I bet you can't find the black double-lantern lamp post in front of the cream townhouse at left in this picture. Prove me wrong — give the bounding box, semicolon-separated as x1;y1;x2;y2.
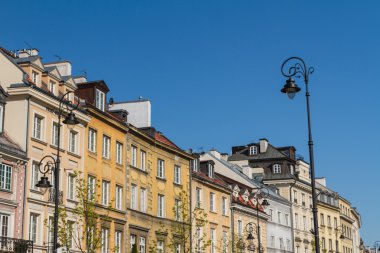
36;91;79;253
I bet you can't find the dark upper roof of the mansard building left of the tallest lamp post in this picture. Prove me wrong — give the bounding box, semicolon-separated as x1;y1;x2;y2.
228;143;289;161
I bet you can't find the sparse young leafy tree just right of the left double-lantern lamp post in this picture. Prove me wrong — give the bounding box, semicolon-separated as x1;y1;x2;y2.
52;172;107;253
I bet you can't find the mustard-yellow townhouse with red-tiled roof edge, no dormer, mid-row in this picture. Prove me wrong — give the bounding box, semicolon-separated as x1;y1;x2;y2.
127;125;192;253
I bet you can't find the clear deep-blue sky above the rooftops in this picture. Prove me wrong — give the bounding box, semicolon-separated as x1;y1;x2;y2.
0;0;380;245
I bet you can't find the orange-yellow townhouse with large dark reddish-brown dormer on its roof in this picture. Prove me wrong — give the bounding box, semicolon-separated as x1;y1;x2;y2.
76;81;128;253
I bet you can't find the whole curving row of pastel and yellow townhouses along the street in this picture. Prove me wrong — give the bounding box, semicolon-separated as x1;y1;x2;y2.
0;46;361;253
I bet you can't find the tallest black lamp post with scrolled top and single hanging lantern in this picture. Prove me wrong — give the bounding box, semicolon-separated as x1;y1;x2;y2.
281;57;320;253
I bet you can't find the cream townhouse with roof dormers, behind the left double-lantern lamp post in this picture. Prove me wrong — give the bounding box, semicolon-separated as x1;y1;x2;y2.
1;49;90;253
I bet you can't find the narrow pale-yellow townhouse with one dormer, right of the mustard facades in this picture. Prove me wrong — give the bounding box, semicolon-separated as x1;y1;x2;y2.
191;159;231;253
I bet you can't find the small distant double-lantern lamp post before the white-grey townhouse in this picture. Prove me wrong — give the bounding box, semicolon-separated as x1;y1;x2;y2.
246;187;269;253
